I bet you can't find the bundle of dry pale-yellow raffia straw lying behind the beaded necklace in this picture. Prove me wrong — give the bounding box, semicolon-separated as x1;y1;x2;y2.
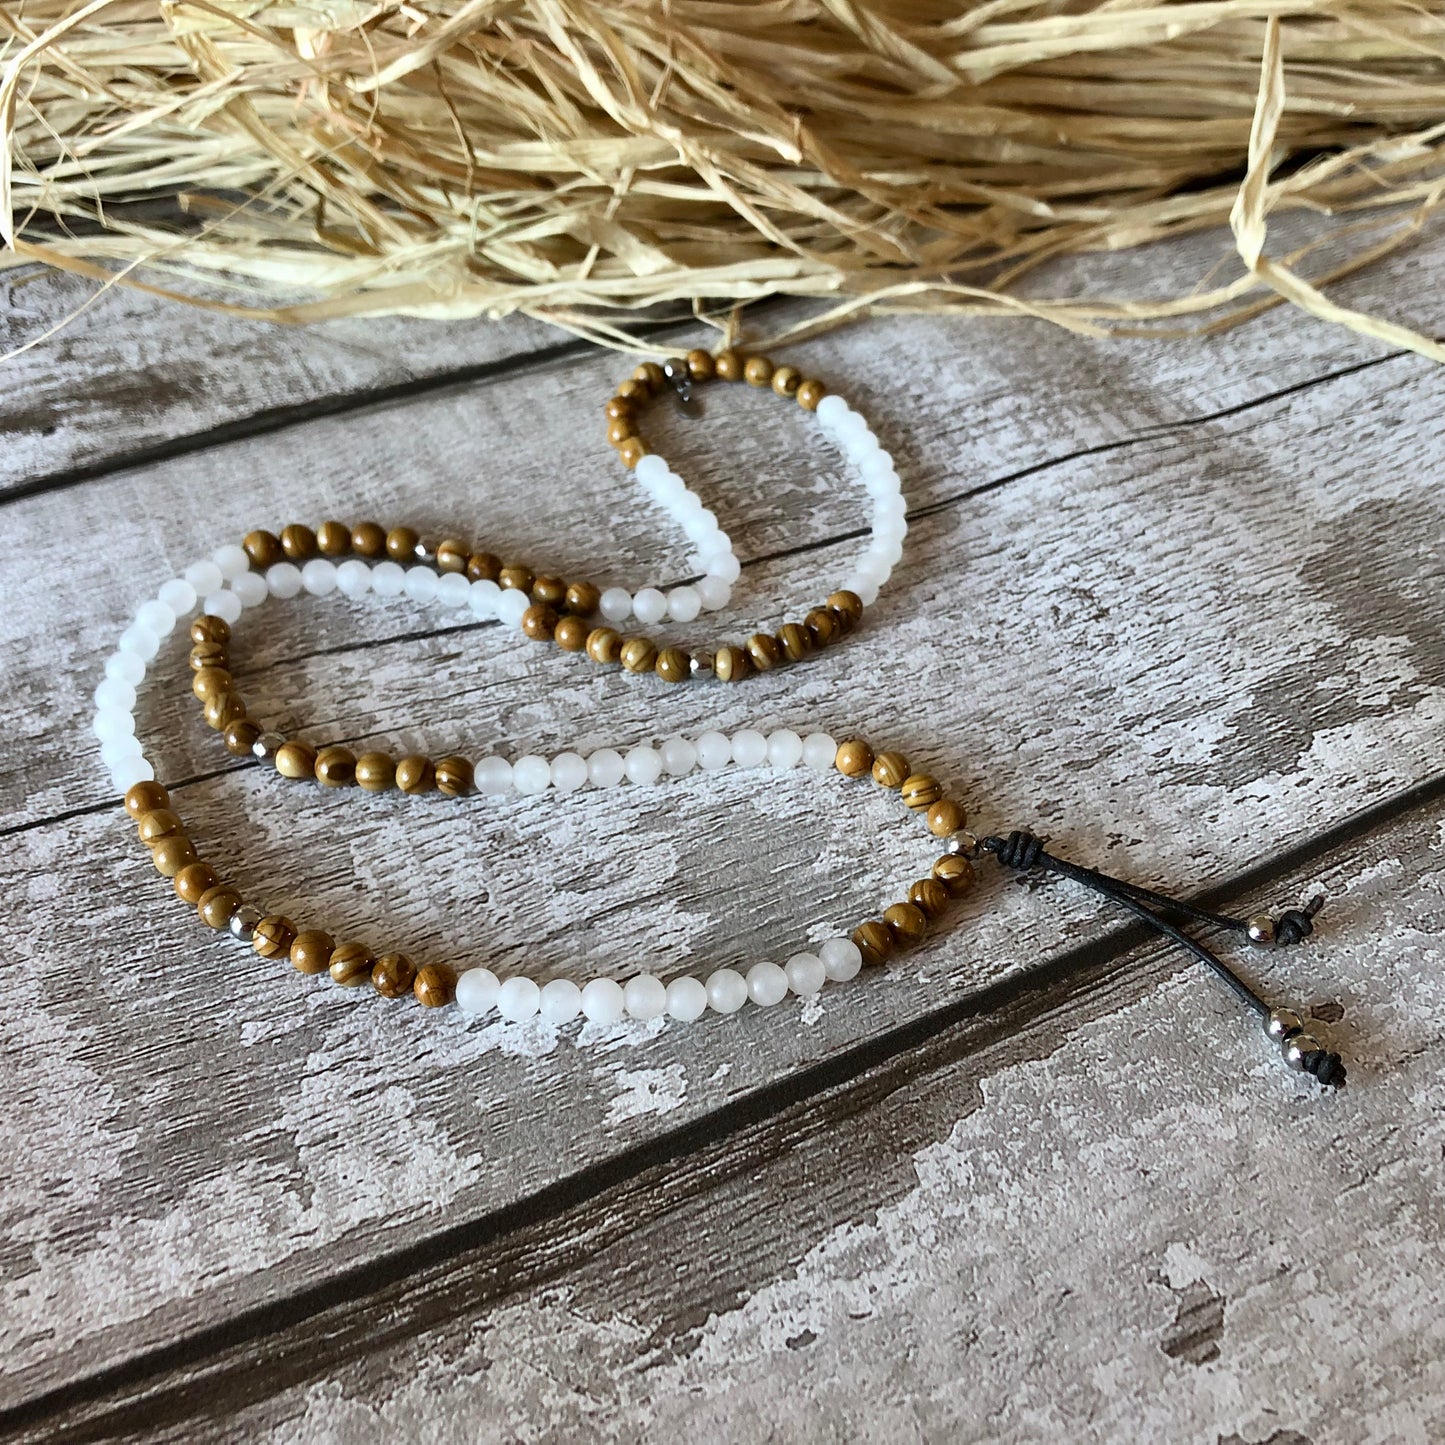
0;0;1445;360
